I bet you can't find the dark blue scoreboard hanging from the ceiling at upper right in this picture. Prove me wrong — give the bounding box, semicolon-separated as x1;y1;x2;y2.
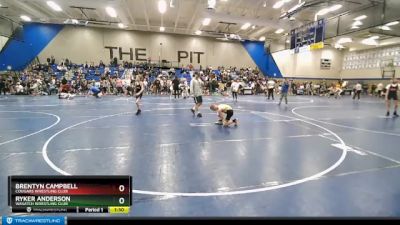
290;19;326;53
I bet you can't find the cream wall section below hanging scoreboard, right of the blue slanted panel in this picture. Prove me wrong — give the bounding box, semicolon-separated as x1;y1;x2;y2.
272;47;343;79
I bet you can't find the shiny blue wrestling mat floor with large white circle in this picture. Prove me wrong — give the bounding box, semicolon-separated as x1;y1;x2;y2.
0;96;400;217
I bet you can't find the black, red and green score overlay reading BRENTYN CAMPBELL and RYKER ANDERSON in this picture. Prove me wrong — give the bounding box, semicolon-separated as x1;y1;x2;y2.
8;176;132;214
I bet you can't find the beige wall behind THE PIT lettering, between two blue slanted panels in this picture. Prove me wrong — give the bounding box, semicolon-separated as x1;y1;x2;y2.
39;26;256;68
